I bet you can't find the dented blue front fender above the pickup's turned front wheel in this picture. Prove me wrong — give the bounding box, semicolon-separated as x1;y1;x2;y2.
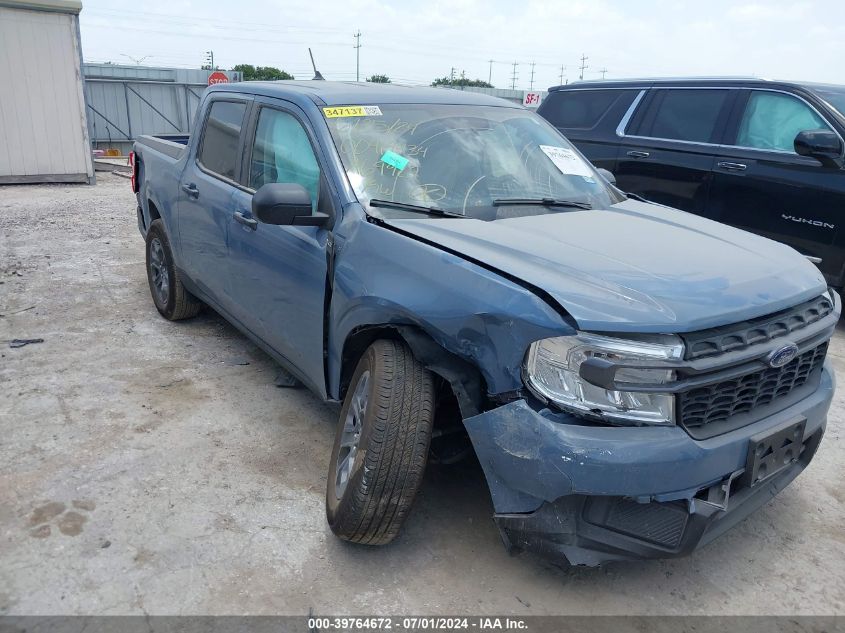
327;211;575;399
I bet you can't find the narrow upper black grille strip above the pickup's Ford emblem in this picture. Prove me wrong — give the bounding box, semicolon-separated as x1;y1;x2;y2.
681;295;833;360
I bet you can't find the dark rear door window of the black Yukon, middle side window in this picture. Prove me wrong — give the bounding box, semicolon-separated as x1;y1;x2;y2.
637;89;728;143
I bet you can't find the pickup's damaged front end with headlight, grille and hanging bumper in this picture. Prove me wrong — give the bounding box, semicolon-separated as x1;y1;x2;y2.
464;293;841;565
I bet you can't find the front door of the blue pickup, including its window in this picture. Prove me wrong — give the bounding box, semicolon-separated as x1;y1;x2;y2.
228;102;331;395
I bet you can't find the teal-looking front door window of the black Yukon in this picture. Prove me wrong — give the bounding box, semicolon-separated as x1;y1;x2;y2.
736;90;830;152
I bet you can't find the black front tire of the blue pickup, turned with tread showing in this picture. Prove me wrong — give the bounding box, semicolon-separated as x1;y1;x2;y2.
326;340;435;545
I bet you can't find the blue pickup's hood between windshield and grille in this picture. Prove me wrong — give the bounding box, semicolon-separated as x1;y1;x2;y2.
385;200;827;332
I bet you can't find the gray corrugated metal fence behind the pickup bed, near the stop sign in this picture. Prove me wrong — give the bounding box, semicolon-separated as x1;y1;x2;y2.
84;64;240;154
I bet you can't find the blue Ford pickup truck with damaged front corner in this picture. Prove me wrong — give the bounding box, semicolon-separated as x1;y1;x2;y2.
132;81;841;565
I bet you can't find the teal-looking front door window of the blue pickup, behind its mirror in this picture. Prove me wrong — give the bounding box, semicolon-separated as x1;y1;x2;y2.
249;108;320;209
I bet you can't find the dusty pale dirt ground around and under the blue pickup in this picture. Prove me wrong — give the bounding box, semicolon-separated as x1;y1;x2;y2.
0;173;845;615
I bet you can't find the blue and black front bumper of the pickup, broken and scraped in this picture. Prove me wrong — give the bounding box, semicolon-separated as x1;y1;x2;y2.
464;363;834;565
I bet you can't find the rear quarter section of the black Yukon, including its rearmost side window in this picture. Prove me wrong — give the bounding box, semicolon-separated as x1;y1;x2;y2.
537;88;642;171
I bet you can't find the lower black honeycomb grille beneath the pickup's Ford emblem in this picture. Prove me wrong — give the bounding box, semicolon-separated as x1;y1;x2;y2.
678;341;827;428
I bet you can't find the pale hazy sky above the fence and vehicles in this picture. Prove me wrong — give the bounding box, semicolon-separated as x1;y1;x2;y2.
81;0;845;90
